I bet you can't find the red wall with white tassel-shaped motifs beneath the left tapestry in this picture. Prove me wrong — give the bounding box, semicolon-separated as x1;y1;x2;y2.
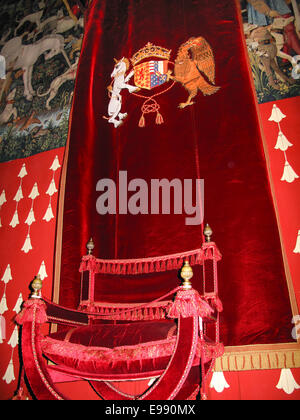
0;147;64;400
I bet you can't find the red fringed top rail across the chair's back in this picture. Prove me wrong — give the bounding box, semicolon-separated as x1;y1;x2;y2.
79;246;222;275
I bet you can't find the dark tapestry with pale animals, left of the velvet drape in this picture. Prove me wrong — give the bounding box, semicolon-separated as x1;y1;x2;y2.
0;0;84;162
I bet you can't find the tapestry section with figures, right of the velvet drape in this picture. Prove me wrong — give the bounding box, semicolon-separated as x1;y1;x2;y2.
240;0;300;103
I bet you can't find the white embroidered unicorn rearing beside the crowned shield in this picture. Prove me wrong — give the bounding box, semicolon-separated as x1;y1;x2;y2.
103;57;139;128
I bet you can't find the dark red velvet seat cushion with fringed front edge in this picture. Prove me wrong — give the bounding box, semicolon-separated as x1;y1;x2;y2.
42;320;199;380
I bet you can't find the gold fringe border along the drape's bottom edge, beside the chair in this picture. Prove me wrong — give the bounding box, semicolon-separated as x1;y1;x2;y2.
214;343;300;372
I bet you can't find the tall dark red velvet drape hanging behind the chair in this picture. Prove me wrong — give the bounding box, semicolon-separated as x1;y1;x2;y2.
60;0;292;345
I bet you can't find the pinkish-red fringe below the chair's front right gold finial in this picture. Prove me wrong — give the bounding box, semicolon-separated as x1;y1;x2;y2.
168;289;214;318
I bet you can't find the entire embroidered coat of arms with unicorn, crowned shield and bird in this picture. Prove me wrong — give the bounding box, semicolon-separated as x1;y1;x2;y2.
104;36;219;128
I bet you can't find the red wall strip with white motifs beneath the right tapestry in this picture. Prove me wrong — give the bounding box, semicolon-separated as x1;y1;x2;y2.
259;96;300;308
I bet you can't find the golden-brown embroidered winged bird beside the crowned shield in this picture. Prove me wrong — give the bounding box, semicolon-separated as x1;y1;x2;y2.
168;37;220;108
